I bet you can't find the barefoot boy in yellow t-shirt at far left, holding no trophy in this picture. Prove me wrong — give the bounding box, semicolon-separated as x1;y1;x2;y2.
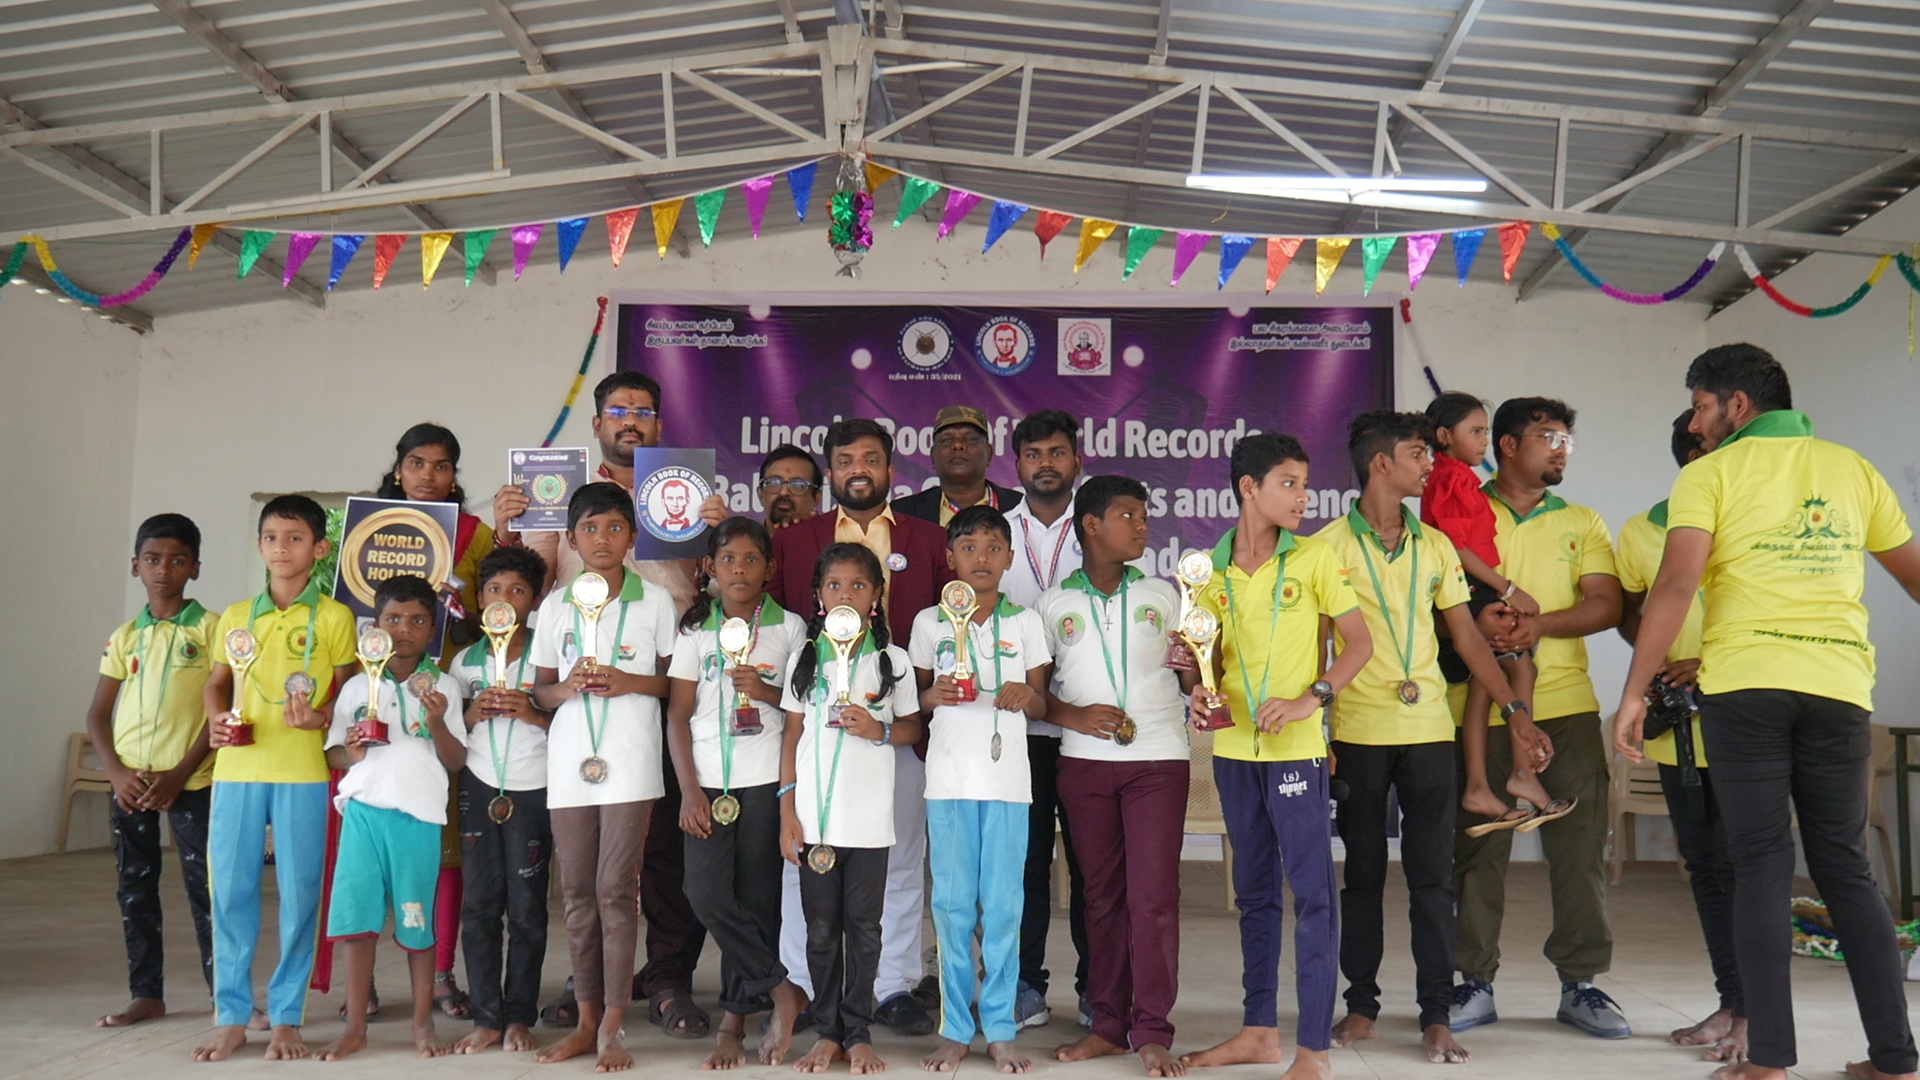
86;513;219;1028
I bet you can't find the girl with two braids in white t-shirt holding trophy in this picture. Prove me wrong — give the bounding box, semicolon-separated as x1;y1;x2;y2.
780;544;920;1074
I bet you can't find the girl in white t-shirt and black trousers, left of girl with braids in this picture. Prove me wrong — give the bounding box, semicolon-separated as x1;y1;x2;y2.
659;517;806;1068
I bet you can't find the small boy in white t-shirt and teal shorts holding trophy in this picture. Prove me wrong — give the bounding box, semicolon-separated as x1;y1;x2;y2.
317;575;467;1061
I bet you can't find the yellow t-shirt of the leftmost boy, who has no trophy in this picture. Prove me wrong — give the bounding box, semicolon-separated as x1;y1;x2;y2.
100;600;221;792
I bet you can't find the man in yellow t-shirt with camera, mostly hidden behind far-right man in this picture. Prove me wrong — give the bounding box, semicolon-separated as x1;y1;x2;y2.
1615;409;1747;1061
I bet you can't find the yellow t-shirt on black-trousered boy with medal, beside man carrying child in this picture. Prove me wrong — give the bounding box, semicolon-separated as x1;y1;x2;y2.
1313;505;1467;746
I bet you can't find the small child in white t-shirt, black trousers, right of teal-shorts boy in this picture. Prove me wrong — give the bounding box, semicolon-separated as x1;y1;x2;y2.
449;548;553;1053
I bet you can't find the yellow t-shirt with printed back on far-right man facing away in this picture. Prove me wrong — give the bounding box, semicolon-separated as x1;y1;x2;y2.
1667;409;1912;709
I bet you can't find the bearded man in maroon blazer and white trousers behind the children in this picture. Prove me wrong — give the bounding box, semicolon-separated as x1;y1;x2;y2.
766;419;954;1036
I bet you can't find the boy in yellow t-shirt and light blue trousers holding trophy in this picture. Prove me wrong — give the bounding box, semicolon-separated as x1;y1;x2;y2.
194;496;355;1061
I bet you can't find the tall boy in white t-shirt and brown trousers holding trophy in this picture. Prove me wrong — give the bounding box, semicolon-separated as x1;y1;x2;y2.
534;482;674;1072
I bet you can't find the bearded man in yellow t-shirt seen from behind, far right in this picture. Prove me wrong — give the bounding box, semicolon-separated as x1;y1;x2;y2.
1613;344;1920;1080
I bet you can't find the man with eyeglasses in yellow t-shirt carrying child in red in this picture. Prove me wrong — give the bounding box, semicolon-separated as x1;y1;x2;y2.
1448;398;1634;1040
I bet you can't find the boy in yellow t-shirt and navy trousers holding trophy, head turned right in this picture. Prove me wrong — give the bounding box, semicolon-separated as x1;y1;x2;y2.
1181;432;1373;1078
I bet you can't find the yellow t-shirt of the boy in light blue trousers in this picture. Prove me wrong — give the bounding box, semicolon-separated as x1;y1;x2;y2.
213;582;353;784
